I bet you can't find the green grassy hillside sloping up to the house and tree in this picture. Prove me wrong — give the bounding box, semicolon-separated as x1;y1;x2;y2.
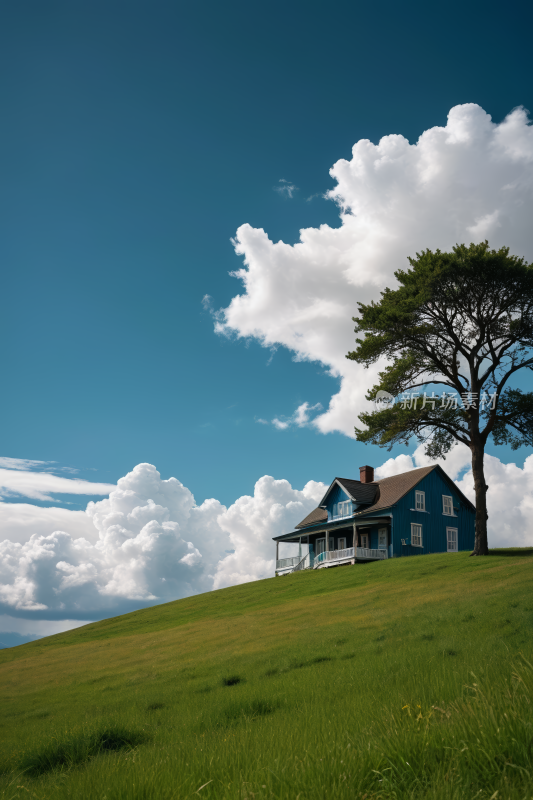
0;550;533;800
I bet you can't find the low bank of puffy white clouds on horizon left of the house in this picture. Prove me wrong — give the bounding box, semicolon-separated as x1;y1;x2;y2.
0;464;325;619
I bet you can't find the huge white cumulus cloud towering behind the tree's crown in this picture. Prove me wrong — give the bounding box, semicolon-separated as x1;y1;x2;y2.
215;103;533;436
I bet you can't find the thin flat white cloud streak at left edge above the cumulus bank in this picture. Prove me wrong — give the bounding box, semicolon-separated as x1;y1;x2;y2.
0;468;115;501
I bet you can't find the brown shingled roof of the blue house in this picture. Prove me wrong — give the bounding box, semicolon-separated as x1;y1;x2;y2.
295;464;474;528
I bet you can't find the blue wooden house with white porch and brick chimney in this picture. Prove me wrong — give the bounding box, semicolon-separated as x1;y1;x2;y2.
274;464;476;575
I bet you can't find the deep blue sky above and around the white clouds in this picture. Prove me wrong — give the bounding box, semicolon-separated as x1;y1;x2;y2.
0;0;533;635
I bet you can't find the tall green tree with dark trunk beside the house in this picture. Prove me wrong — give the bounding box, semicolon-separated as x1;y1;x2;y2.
347;242;533;555
